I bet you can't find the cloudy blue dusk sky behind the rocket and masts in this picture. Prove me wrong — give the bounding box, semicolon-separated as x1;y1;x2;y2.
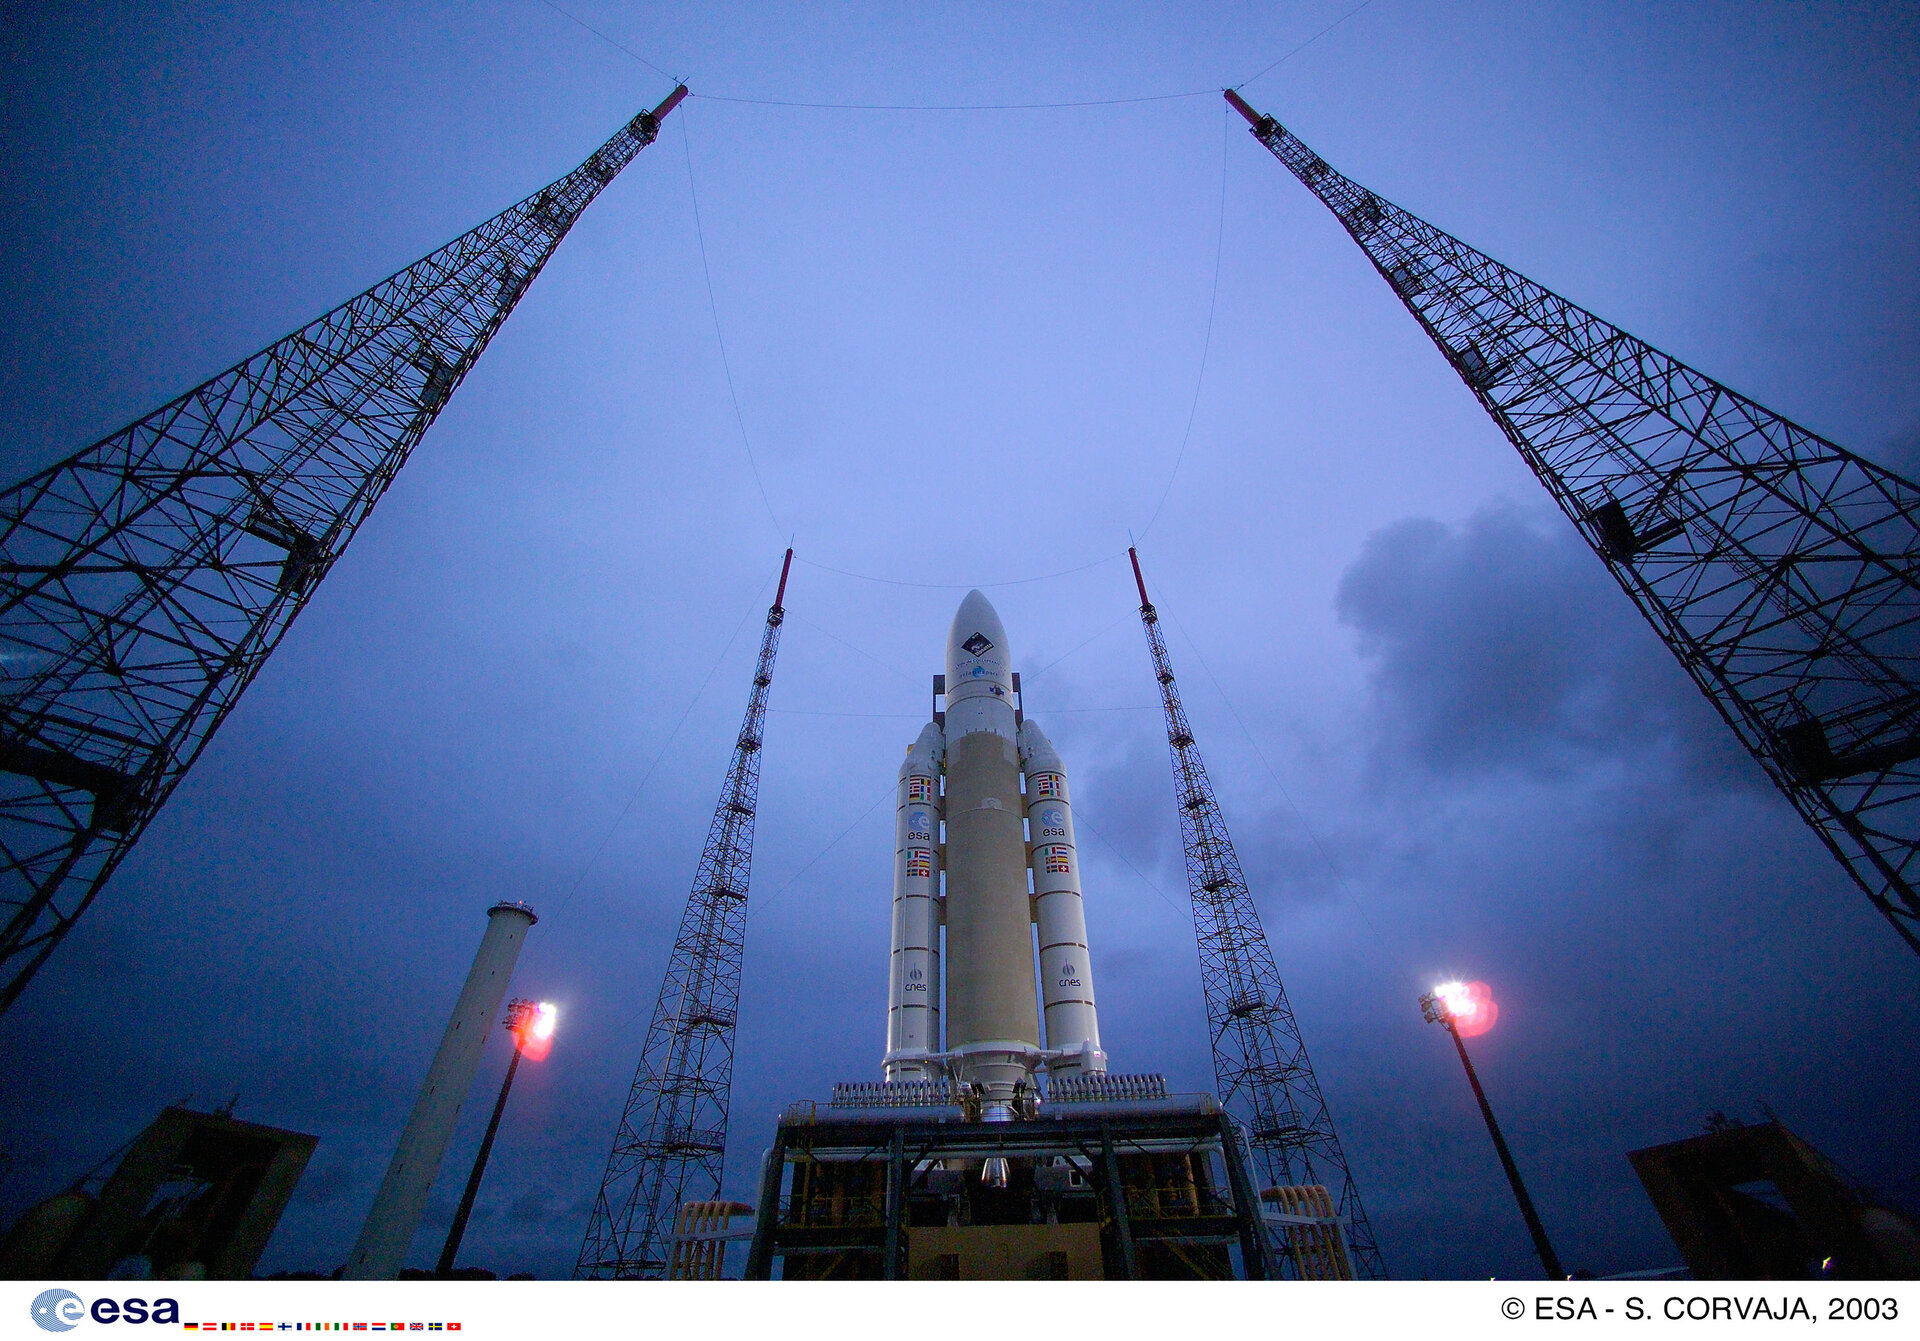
0;0;1920;1278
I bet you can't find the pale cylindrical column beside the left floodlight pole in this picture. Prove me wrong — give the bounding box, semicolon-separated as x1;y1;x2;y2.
346;903;538;1280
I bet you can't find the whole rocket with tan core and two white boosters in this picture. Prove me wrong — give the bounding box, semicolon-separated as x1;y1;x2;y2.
885;592;1106;1120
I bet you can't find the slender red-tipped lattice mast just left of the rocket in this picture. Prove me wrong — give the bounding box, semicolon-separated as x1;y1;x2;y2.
574;549;793;1280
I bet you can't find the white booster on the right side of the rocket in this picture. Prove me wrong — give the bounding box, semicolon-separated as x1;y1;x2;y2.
1020;717;1106;1076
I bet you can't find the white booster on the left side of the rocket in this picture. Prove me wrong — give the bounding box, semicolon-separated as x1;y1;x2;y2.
885;722;947;1080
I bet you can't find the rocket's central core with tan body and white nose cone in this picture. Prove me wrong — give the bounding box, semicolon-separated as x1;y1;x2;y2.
945;592;1041;1118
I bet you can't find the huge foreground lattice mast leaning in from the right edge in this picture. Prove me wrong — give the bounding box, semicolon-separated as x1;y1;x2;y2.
1227;90;1920;951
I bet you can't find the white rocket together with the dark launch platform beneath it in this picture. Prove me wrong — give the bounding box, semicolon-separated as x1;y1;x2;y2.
745;592;1352;1280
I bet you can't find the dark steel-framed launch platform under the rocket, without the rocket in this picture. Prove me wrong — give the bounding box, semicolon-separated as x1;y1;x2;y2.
745;1076;1344;1280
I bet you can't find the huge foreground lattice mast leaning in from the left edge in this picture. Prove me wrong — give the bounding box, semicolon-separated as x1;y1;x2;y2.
0;86;687;1011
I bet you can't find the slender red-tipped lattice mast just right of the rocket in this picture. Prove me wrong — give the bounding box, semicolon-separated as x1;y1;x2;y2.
1127;549;1386;1280
